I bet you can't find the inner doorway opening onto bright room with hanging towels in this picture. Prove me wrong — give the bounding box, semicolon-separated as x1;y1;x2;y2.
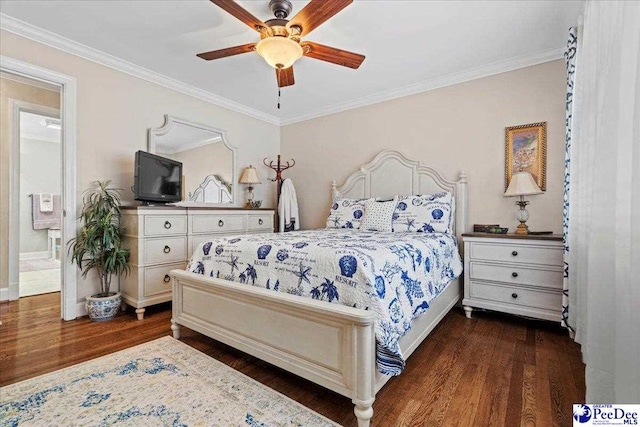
12;110;63;298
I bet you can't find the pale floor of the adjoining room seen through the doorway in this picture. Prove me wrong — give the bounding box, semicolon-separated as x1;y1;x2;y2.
18;258;60;297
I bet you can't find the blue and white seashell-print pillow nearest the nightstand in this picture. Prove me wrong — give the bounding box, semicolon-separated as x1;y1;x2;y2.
393;192;455;234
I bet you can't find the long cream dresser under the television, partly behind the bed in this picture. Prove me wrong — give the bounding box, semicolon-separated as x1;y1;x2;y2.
120;206;274;320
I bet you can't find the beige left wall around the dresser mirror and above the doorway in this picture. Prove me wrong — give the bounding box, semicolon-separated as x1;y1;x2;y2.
0;31;280;302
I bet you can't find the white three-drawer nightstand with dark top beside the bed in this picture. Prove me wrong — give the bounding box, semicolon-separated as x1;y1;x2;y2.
462;233;563;322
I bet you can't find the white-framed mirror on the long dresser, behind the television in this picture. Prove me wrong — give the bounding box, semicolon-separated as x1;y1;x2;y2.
148;114;237;205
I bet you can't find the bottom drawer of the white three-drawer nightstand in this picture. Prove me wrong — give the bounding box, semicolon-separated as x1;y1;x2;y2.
470;281;562;313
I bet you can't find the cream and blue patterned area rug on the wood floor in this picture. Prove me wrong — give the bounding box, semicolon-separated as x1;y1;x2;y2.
0;337;337;427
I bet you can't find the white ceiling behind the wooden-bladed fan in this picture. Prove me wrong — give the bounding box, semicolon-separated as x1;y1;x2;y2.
0;0;583;124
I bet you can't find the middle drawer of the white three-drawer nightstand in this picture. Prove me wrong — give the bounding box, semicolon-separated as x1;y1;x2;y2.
469;261;562;290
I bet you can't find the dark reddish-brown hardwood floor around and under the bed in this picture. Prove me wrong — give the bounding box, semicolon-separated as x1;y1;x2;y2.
0;293;585;427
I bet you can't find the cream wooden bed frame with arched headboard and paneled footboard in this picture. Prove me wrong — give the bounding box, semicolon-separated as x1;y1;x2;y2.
171;150;467;426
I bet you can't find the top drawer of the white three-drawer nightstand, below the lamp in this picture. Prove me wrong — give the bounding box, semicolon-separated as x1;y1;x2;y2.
470;242;563;267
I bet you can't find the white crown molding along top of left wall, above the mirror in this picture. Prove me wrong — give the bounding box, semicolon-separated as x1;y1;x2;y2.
0;13;281;126
